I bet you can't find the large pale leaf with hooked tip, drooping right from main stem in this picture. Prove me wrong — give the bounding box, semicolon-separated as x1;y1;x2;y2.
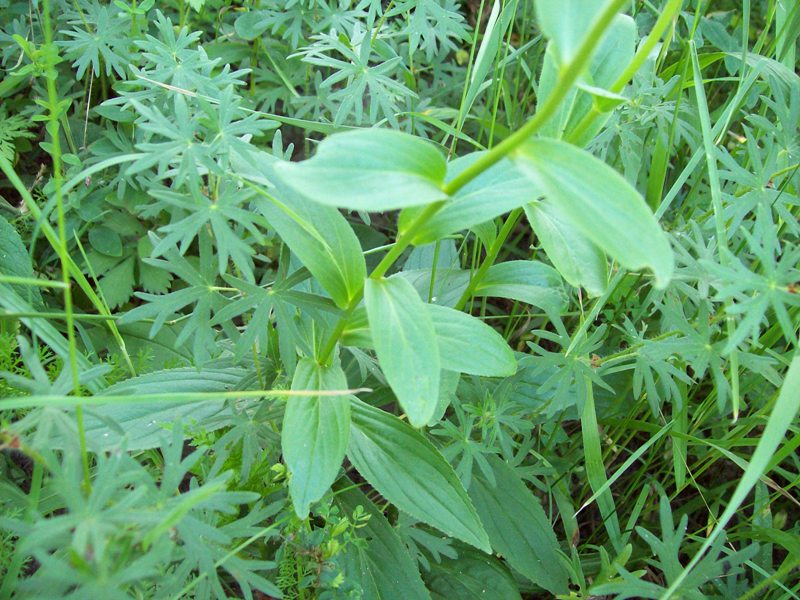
515;138;674;287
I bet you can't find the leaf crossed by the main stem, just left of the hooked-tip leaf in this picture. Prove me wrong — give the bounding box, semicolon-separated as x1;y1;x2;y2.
398;158;542;245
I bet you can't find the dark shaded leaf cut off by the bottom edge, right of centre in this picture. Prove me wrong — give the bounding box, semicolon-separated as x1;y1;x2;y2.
425;547;521;600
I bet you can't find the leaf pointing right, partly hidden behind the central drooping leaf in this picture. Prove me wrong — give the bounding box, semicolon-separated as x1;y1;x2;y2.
425;304;517;377
